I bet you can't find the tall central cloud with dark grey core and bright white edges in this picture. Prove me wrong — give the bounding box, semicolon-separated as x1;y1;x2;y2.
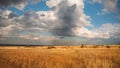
47;0;92;36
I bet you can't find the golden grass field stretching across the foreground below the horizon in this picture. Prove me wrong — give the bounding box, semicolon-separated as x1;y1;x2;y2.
0;45;120;68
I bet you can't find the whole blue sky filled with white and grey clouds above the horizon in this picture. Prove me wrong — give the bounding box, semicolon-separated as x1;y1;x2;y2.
0;0;120;45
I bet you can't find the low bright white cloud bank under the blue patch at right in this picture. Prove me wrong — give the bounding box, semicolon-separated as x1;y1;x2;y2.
74;23;120;39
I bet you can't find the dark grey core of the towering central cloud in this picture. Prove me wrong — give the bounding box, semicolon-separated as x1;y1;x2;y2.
53;1;80;36
